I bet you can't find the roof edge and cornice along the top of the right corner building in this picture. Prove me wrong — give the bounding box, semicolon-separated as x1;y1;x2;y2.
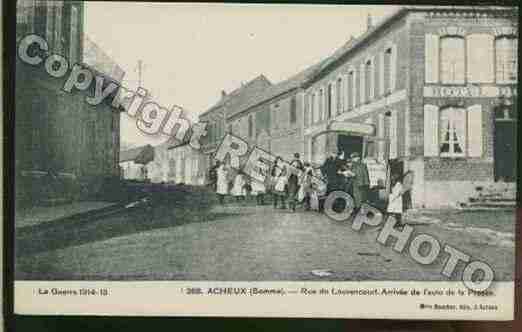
309;5;510;82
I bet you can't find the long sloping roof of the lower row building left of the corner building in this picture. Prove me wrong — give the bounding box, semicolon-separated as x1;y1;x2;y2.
227;58;328;117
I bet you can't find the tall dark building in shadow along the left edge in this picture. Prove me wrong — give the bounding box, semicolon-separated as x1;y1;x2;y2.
15;0;120;204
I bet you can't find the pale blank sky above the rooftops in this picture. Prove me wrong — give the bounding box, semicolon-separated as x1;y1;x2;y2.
84;1;396;146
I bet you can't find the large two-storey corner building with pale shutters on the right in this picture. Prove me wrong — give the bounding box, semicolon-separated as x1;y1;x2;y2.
304;6;518;207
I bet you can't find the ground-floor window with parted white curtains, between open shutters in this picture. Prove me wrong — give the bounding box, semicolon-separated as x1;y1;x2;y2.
439;107;466;157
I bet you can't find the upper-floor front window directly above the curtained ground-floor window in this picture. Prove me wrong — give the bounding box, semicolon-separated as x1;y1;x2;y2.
440;36;465;84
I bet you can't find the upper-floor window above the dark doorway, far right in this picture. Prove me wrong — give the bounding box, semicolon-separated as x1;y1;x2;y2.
495;36;518;83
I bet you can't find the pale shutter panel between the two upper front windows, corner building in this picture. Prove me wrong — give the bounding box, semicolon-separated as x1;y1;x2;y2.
467;34;495;83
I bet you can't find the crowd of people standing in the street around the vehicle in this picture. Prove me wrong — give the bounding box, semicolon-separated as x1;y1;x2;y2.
206;151;402;219
